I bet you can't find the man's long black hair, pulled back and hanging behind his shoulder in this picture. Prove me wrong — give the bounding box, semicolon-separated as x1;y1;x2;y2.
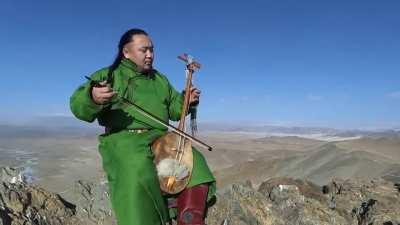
107;28;148;83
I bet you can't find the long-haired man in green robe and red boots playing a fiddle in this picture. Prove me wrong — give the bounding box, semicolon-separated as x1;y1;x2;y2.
70;29;215;225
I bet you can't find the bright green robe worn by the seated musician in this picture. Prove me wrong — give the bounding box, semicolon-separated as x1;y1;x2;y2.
70;59;216;225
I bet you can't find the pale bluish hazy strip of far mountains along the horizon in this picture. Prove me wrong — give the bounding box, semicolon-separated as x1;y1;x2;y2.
0;116;400;141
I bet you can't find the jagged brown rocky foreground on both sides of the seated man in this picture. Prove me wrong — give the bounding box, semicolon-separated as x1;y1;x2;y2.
0;168;400;225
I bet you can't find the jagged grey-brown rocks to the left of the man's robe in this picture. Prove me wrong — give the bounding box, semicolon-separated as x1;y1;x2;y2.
0;168;116;225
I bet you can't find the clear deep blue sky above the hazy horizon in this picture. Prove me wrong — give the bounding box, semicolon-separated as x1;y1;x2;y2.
0;0;400;129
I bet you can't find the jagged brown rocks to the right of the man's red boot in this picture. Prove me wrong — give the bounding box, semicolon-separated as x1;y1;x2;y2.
207;178;400;225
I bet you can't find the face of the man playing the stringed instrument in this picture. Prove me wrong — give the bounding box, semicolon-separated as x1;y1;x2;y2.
123;34;154;72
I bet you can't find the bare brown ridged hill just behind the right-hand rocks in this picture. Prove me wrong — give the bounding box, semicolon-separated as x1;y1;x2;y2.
215;140;400;186
